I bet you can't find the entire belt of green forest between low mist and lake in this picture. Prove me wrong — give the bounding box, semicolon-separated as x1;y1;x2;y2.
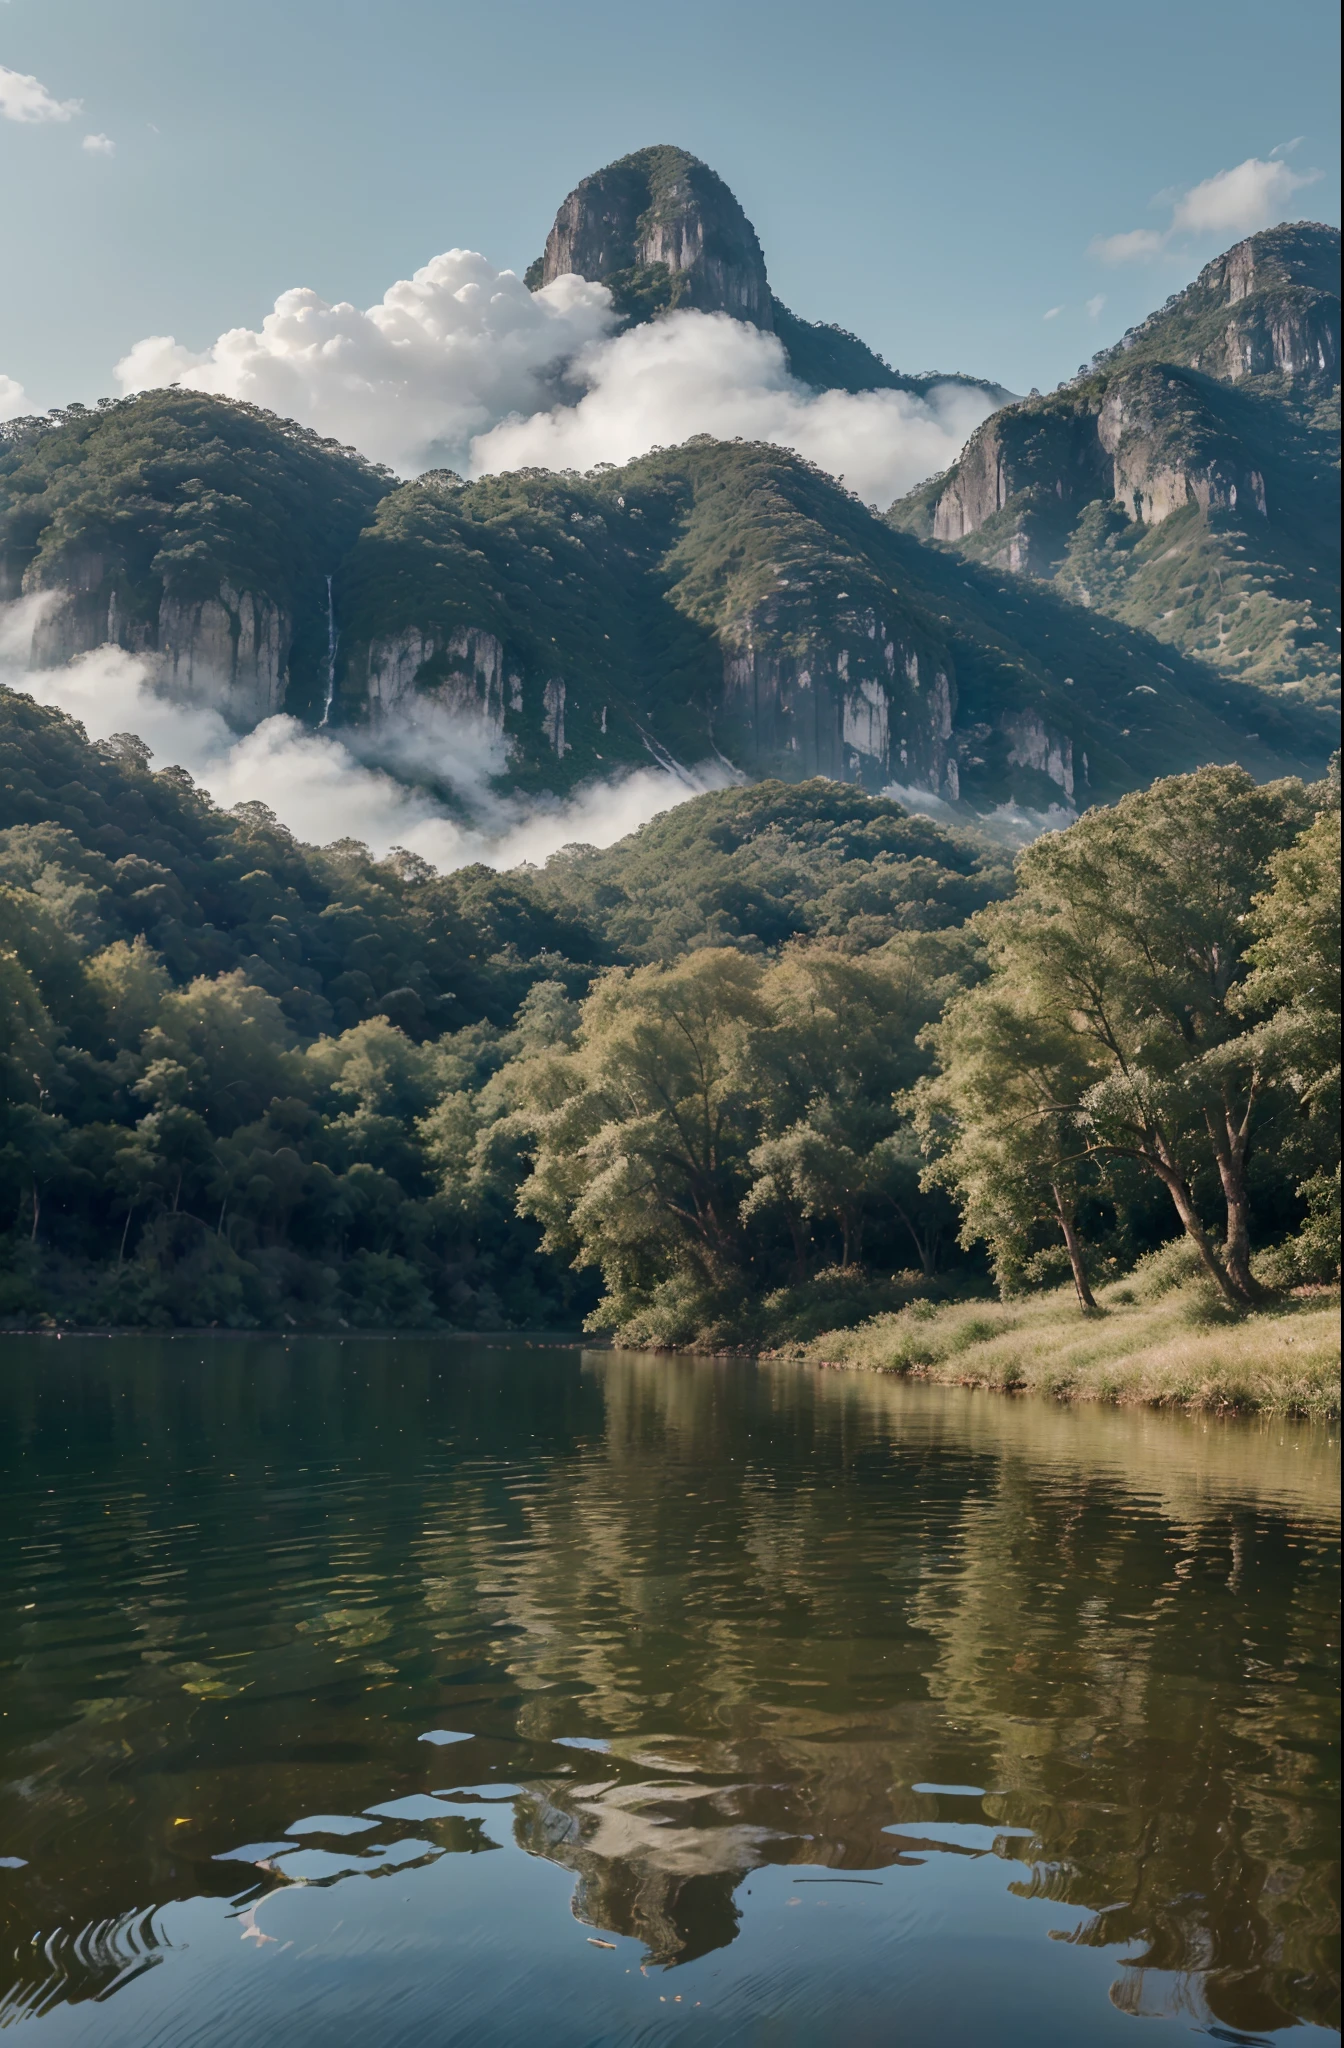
0;692;1340;1343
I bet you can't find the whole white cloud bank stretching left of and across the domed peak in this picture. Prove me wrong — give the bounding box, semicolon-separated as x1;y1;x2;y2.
117;250;994;502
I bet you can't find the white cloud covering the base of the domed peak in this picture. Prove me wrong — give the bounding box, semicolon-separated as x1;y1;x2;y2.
471;311;996;504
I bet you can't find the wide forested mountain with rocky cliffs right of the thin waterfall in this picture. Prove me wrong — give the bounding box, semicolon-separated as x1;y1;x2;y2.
329;444;1328;813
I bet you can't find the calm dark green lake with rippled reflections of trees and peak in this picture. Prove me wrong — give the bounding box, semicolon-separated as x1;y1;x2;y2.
0;1337;1338;2048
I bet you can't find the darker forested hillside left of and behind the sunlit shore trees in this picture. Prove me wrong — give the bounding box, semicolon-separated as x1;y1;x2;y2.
0;690;995;1329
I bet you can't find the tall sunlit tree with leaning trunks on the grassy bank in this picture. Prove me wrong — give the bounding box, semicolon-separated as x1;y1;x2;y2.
946;768;1307;1303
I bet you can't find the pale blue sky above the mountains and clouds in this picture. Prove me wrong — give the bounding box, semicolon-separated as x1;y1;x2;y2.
0;0;1340;410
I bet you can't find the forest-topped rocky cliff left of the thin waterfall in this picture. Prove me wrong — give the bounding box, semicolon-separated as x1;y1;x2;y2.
0;389;391;729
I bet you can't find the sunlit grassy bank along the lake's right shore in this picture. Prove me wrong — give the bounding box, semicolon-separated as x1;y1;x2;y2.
795;1274;1340;1421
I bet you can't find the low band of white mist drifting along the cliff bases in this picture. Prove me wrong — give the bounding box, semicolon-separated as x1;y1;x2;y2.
0;596;731;870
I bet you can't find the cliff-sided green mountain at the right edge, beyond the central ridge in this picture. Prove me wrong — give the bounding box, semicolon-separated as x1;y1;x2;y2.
889;223;1340;700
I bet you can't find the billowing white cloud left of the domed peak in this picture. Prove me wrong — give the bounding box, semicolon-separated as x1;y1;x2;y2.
117;250;615;471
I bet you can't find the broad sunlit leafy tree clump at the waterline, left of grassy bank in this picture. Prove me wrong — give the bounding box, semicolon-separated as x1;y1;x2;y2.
506;936;969;1343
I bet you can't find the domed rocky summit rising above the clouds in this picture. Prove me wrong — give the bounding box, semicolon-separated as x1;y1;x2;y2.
541;145;774;328
